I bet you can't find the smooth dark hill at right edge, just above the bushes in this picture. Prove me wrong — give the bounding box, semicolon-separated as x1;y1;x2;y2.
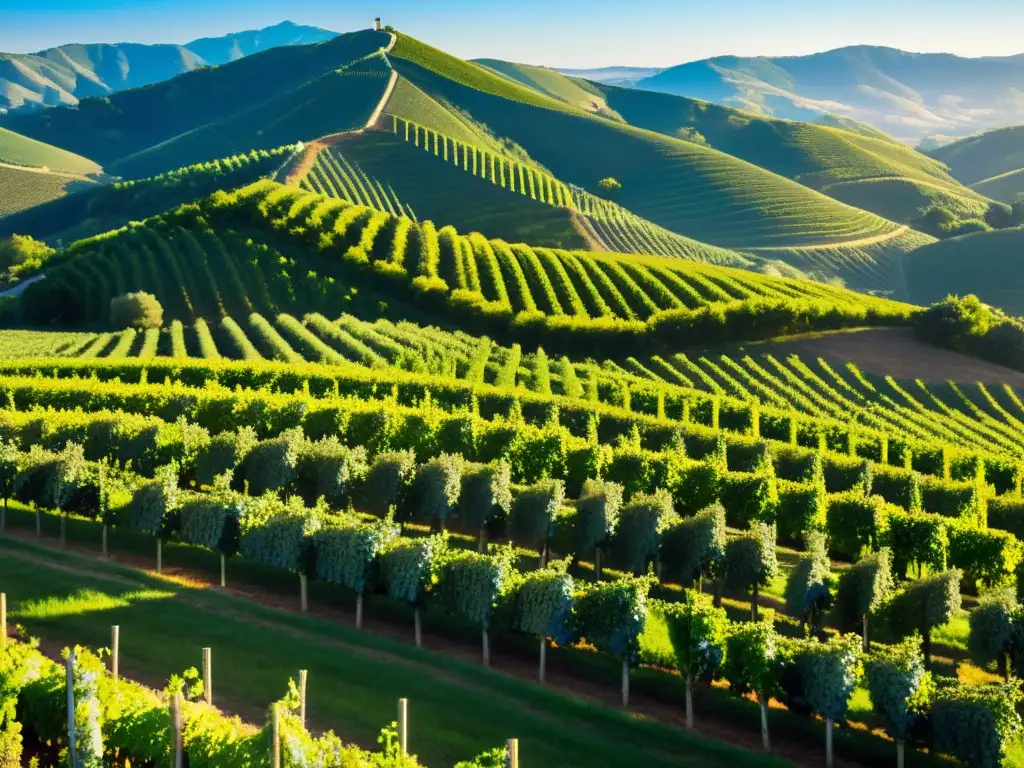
904;228;1024;315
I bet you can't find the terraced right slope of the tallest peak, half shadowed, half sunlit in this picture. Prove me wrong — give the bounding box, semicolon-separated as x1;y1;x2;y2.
392;36;929;290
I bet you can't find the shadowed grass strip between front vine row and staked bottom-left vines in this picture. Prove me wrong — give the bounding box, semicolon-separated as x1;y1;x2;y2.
0;541;784;768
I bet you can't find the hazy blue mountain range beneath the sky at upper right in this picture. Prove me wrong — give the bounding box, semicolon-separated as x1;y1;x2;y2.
635;46;1024;141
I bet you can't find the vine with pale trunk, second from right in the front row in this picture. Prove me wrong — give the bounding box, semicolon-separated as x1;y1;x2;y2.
864;636;932;768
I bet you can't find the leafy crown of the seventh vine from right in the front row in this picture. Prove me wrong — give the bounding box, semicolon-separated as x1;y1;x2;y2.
512;561;574;645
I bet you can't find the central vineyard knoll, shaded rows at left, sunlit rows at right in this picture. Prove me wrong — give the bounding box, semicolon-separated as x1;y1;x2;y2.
24;181;906;338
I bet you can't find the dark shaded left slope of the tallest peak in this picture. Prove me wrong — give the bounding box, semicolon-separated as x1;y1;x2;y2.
5;31;390;177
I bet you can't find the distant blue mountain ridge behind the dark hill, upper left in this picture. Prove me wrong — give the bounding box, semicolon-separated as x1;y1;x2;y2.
0;22;337;114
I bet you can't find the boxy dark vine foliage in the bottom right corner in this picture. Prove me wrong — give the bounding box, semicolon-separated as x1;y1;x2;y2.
932;681;1022;768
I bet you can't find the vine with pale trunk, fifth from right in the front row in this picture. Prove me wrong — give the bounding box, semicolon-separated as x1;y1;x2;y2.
662;590;729;728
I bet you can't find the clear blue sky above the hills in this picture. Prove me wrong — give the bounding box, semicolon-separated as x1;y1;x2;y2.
6;0;1024;67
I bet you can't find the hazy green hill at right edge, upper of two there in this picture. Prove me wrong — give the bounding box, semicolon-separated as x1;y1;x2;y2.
930;126;1024;203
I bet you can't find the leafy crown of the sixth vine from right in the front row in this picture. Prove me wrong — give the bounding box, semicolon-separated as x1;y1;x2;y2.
574;575;655;664
